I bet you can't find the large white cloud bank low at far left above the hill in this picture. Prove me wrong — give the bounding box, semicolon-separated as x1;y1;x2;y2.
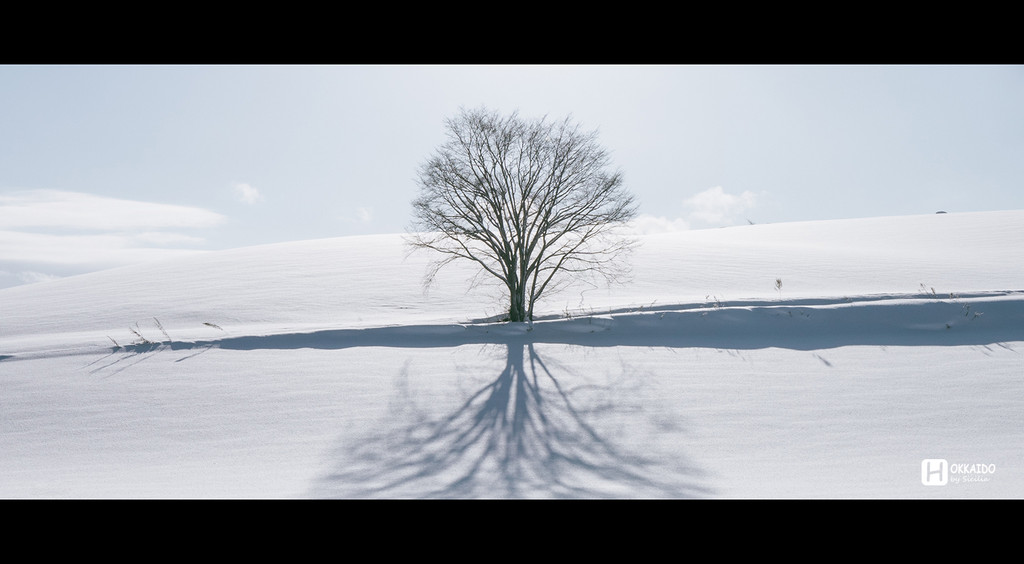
0;189;226;287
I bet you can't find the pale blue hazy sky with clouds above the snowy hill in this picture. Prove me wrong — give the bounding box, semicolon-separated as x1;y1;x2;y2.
0;64;1024;288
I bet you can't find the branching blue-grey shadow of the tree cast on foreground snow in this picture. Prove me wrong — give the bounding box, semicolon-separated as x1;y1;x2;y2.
311;343;709;498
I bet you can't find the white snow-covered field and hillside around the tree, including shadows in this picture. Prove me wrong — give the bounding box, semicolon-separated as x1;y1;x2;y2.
0;211;1024;498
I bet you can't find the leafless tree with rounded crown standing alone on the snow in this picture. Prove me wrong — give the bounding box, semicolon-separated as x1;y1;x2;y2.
408;109;636;321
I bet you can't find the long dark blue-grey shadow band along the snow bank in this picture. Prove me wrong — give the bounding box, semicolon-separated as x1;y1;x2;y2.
155;299;1024;350
